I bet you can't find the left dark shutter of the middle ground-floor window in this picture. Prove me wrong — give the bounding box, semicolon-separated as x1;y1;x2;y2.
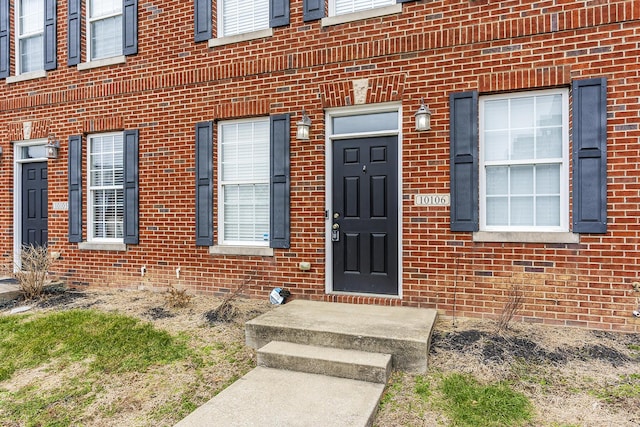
196;122;213;246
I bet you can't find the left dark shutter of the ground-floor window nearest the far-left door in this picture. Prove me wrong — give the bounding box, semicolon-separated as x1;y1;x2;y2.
67;135;82;243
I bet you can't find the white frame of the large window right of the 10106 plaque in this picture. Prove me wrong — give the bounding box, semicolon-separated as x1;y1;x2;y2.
479;89;570;233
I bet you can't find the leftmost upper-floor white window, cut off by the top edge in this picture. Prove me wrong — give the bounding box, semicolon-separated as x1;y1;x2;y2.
16;0;44;74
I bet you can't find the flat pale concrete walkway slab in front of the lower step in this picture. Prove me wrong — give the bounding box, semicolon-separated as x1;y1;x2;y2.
176;366;385;427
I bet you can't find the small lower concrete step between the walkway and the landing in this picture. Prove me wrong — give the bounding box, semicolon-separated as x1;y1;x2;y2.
258;341;391;384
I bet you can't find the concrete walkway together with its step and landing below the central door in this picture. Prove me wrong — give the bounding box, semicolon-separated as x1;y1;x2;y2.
176;300;436;427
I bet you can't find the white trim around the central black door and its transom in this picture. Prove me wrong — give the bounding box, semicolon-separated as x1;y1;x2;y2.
325;102;403;299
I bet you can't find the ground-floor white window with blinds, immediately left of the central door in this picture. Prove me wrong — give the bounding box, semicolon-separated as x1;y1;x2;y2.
218;118;270;246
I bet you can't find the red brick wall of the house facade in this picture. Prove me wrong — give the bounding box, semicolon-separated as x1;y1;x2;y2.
0;0;640;331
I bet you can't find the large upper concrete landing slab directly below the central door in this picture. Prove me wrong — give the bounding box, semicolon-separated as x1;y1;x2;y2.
245;300;437;373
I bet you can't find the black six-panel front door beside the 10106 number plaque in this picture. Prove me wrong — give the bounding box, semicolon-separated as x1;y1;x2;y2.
330;136;398;295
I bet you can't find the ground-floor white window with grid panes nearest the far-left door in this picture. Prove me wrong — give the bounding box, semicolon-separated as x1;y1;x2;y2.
88;133;124;242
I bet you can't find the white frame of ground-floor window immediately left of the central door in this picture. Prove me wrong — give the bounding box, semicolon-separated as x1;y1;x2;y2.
217;117;271;248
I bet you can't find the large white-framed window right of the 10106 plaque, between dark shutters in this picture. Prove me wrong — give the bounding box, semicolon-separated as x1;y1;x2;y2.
480;90;569;231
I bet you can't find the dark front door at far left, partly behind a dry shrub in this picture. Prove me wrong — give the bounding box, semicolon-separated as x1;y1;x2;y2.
22;162;49;246
